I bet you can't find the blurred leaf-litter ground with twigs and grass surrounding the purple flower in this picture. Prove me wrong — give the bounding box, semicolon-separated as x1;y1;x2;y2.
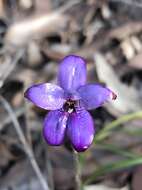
0;0;142;190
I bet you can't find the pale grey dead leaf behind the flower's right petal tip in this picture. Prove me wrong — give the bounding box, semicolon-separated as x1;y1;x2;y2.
94;52;142;114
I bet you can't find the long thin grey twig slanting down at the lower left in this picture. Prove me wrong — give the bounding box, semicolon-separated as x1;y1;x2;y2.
0;95;49;190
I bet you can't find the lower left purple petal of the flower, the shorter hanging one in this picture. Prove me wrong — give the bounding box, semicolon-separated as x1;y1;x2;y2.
43;110;68;146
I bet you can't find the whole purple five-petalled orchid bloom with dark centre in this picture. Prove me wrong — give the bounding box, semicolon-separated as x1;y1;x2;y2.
25;55;116;152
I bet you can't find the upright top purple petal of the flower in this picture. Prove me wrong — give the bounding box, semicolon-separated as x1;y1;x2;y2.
58;55;86;91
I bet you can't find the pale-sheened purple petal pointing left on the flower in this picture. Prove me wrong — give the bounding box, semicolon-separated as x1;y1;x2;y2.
25;83;65;110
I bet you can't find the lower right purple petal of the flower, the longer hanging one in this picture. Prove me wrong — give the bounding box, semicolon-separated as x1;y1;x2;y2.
67;110;94;152
